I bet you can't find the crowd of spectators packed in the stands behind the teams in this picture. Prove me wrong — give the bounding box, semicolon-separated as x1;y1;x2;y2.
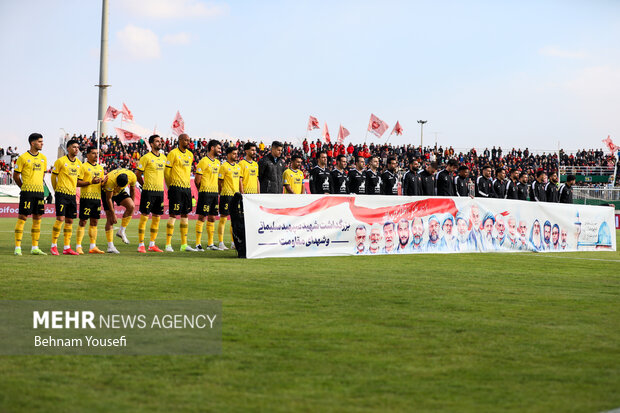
12;134;620;186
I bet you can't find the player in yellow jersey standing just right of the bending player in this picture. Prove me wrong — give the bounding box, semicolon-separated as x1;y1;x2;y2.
136;135;166;253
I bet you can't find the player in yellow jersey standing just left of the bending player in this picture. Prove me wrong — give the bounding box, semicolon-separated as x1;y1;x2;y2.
75;146;105;255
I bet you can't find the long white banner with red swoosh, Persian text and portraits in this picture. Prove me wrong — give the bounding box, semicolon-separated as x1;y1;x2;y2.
243;194;616;258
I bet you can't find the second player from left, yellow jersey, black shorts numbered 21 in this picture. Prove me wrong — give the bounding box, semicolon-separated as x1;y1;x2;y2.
50;139;82;255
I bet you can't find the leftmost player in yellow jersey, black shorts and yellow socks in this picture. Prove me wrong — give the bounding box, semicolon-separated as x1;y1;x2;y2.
13;133;47;255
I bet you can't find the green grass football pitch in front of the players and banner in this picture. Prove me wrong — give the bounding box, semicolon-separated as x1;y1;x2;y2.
0;219;620;412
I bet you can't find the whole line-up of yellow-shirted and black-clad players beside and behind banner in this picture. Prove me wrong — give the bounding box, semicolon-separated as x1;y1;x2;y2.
14;133;574;255
